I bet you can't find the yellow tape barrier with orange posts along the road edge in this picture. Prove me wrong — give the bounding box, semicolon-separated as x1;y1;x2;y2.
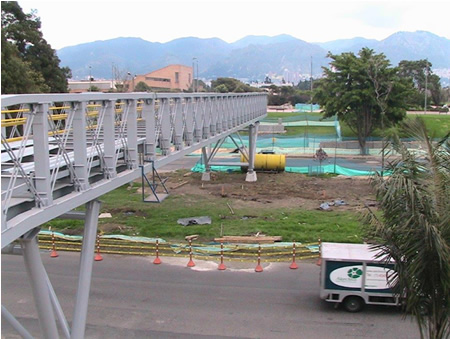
39;231;319;263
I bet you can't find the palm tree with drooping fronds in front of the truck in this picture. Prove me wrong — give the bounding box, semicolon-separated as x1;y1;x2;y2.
366;118;450;339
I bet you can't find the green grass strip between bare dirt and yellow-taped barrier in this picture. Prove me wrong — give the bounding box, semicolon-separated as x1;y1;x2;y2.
44;184;362;243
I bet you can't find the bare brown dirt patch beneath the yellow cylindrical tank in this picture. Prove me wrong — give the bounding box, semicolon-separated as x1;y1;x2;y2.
164;172;375;214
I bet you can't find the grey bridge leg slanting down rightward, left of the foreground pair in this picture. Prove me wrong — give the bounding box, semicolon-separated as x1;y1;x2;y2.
20;227;59;339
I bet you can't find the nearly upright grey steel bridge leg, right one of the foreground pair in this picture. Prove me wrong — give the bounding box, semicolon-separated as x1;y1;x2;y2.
71;200;101;339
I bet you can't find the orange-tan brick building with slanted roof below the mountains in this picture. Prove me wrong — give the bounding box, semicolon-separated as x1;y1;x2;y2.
129;65;193;92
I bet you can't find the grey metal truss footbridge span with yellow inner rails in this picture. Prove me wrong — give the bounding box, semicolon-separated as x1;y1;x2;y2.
1;93;267;247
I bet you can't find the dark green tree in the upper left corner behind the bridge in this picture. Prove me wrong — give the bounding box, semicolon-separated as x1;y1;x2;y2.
1;1;71;94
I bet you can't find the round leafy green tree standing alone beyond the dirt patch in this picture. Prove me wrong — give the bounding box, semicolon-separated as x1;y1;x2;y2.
313;48;411;154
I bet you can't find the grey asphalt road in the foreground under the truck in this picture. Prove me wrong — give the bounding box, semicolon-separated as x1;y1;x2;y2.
1;252;419;339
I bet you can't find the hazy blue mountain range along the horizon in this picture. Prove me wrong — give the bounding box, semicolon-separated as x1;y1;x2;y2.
57;31;450;81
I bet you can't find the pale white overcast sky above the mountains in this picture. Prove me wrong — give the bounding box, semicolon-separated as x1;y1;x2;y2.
19;0;450;49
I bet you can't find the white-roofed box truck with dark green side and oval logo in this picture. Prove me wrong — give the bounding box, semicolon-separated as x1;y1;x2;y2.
320;242;401;312
